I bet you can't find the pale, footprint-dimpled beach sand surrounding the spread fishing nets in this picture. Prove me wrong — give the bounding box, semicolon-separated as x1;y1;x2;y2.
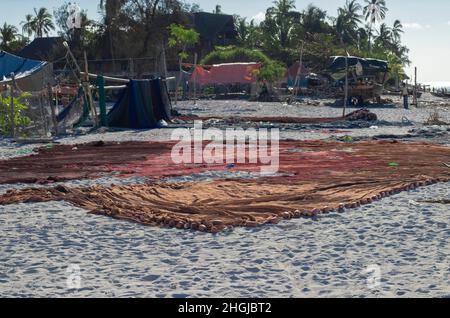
0;99;450;297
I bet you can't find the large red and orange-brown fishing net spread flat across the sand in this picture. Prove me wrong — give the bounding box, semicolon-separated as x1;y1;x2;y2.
0;141;450;233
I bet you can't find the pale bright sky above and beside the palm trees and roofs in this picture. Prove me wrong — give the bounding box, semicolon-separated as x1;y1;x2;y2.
0;0;450;82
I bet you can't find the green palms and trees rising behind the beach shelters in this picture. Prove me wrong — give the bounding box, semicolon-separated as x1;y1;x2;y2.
0;0;411;79
